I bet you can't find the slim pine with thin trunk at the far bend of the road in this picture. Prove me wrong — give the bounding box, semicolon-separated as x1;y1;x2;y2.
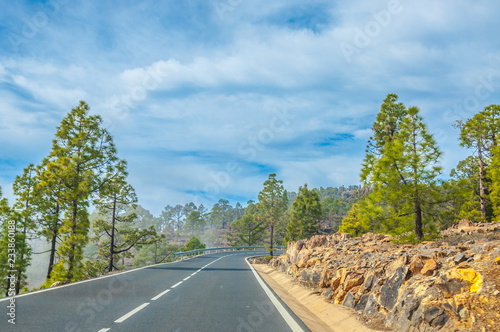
257;173;287;256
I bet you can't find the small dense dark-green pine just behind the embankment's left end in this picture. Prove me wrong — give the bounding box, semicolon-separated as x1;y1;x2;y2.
284;184;322;244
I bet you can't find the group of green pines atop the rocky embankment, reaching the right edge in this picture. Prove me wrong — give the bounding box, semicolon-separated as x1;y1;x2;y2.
340;94;500;241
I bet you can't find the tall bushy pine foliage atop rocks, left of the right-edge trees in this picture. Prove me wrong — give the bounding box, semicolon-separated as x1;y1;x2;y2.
348;94;441;239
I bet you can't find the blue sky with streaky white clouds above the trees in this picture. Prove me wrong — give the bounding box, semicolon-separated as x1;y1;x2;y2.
0;0;500;215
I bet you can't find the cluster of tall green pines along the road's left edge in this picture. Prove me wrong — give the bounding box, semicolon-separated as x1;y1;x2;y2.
0;101;159;294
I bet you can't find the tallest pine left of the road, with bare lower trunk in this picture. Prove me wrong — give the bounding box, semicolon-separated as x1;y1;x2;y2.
47;101;117;281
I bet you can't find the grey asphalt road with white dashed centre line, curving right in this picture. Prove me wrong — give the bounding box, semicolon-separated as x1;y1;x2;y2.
0;252;308;332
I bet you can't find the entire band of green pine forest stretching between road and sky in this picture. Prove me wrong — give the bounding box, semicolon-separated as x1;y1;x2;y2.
0;94;500;295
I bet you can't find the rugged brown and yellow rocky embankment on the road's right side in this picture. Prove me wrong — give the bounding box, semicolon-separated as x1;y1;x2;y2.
269;221;500;332
